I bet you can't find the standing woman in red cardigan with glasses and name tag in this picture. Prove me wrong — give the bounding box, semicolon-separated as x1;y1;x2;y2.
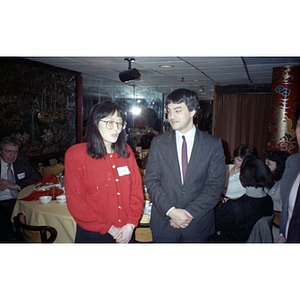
65;101;144;243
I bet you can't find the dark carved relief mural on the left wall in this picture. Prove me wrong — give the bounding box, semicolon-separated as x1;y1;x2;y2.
0;58;77;158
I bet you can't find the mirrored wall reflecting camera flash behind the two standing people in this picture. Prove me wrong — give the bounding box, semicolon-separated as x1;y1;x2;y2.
82;74;166;150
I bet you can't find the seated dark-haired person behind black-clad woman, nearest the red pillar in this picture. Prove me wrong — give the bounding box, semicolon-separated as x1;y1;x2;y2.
265;150;290;212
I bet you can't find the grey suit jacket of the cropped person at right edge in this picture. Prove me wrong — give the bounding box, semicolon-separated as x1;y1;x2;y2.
279;152;300;238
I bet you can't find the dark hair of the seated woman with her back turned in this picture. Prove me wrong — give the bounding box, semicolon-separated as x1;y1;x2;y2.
240;156;274;188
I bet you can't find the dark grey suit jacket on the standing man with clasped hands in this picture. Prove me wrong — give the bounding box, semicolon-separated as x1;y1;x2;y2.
144;129;225;239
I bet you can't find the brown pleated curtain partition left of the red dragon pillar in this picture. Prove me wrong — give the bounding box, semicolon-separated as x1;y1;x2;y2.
213;92;272;163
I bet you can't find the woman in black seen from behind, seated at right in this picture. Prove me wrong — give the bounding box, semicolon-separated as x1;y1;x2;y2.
210;157;274;243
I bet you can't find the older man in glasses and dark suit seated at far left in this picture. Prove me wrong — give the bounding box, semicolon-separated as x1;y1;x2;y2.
0;136;41;238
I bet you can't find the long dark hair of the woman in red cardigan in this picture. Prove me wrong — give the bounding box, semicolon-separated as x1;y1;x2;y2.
85;101;129;159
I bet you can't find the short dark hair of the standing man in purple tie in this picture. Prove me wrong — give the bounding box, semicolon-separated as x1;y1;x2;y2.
166;89;199;116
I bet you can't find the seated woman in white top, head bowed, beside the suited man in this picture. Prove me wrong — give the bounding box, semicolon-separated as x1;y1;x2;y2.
221;145;258;201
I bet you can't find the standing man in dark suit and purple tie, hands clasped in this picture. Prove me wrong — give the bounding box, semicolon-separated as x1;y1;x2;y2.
144;89;225;243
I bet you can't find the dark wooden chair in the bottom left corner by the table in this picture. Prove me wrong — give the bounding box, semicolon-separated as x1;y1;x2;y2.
13;213;57;243
